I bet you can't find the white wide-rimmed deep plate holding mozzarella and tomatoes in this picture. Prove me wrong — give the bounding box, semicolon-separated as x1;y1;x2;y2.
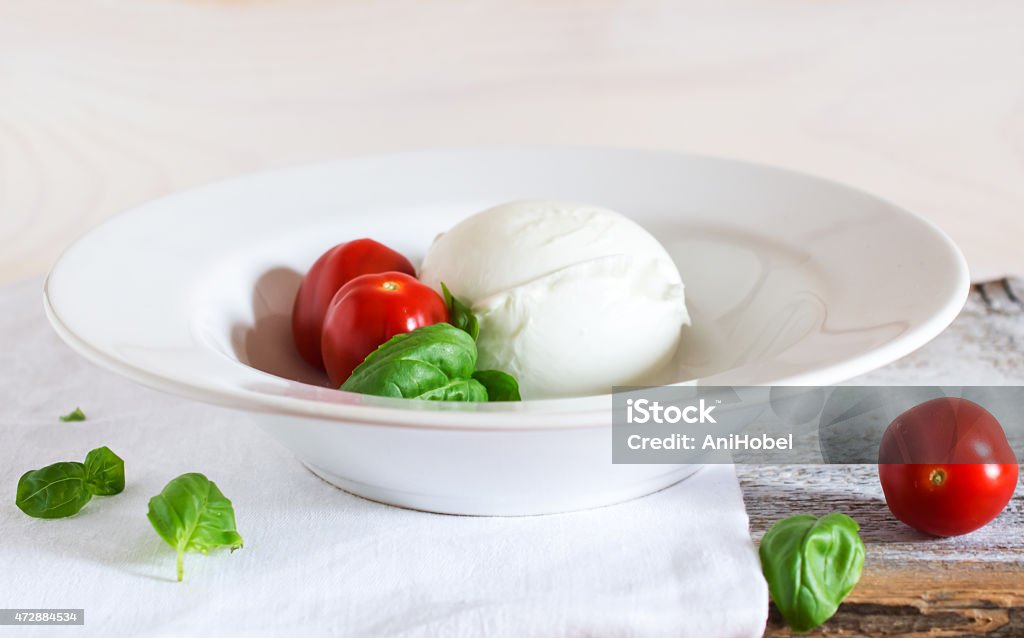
46;147;968;514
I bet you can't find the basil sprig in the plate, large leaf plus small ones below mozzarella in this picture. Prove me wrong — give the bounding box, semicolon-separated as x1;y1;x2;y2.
341;324;519;401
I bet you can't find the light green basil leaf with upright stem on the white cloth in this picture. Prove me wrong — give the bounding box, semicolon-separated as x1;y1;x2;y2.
146;473;242;582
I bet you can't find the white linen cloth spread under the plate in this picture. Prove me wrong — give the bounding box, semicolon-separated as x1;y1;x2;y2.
0;280;768;638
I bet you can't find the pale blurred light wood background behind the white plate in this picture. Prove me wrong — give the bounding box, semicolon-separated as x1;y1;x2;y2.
0;0;1024;283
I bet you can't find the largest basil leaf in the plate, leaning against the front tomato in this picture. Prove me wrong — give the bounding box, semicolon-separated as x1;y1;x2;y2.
341;324;476;400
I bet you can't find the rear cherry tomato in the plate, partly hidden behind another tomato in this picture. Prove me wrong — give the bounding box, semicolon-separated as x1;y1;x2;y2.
292;240;416;370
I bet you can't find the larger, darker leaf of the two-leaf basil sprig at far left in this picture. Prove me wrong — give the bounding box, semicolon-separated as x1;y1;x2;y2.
14;461;92;518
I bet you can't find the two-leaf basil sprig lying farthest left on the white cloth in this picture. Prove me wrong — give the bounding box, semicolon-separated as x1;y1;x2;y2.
14;446;125;518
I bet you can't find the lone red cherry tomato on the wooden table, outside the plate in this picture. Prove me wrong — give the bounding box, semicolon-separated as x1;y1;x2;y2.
879;397;1018;537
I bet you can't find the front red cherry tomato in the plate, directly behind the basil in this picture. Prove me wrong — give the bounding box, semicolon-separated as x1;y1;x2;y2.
321;272;449;387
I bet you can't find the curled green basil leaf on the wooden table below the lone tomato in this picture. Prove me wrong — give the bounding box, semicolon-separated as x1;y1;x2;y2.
759;513;864;632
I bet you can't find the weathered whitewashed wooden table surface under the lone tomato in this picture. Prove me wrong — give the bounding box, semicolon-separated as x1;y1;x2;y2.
753;286;1024;638
